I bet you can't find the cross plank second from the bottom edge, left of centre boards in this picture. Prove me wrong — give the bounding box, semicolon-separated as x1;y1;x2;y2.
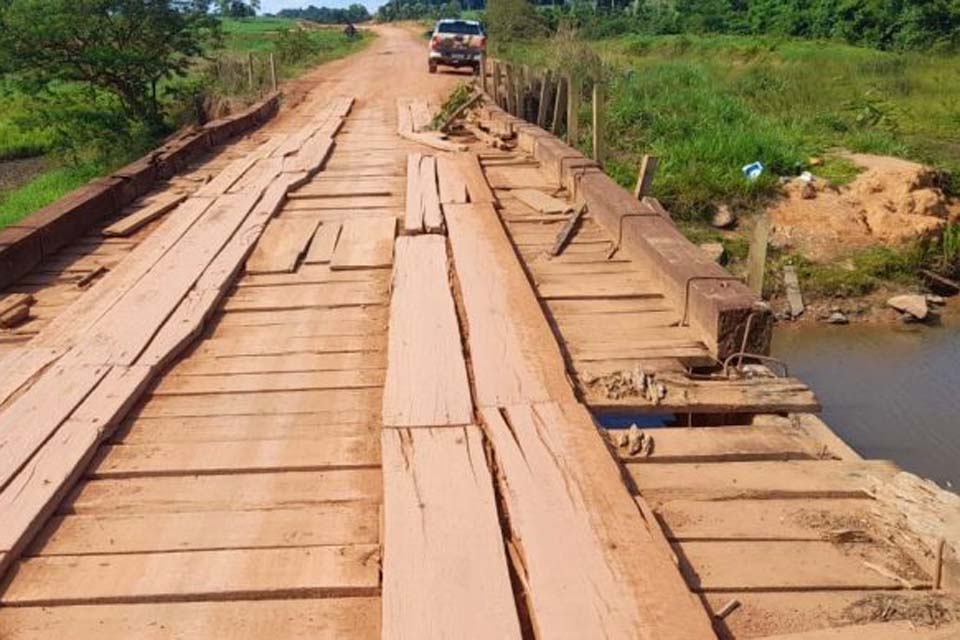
0;545;380;606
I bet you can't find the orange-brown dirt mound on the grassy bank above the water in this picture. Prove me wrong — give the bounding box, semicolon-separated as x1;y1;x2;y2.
770;154;960;261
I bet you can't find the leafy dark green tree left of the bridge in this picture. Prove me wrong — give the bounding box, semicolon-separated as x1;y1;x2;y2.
0;0;218;128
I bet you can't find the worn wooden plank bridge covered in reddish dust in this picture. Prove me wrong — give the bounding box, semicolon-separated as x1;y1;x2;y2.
0;28;960;640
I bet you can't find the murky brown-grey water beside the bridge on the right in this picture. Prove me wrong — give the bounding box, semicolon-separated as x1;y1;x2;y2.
773;314;960;491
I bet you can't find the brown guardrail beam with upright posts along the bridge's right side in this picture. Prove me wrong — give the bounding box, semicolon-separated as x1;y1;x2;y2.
481;59;773;361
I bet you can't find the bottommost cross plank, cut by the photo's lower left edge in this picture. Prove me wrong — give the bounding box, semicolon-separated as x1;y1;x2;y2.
0;597;380;640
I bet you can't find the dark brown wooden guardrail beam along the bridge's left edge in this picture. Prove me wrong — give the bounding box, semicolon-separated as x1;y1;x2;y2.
0;93;280;287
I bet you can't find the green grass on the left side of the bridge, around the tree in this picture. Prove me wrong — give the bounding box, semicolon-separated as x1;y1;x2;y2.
0;18;373;228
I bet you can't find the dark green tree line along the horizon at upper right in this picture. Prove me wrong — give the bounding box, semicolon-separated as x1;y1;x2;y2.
377;0;960;50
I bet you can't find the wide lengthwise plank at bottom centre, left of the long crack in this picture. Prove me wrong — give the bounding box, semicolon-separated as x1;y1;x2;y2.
382;426;521;638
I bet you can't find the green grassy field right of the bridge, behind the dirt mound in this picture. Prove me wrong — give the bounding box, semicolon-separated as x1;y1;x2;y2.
500;35;960;295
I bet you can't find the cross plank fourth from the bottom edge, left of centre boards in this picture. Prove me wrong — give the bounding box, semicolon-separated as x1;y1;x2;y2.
63;469;383;515
